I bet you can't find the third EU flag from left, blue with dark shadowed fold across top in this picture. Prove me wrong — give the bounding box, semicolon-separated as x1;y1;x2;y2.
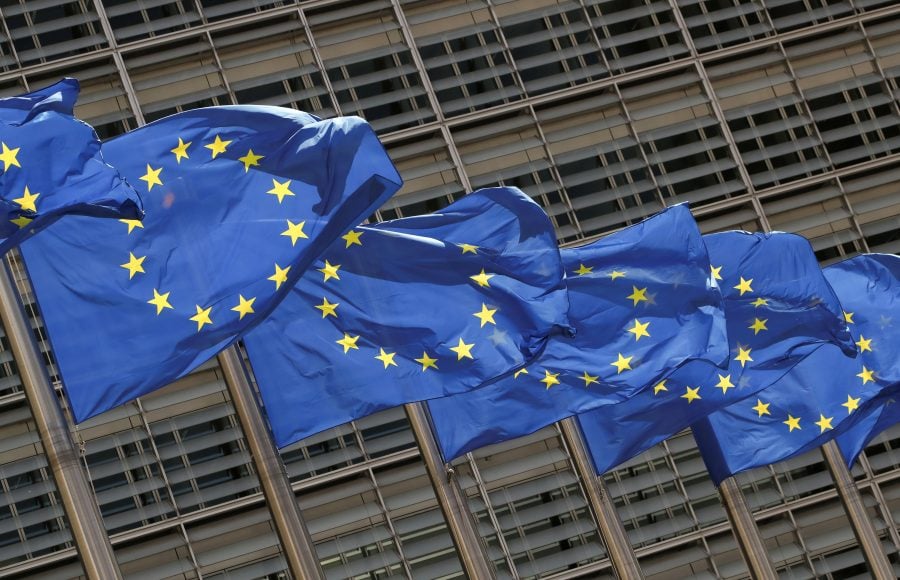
244;188;568;447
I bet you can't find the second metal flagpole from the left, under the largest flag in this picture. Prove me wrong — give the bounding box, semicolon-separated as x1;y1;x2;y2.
217;346;325;580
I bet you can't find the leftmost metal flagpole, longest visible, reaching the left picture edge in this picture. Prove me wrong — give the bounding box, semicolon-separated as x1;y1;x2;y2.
0;260;122;580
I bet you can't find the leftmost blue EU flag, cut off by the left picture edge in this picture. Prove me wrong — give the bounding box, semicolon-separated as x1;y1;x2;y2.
0;79;142;255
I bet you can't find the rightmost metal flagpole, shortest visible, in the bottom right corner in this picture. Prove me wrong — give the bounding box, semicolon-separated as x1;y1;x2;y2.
821;440;896;580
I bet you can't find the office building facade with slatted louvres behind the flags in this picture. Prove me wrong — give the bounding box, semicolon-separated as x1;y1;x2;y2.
0;0;900;580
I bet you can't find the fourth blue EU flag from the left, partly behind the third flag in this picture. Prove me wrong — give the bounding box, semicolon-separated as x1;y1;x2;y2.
429;205;728;461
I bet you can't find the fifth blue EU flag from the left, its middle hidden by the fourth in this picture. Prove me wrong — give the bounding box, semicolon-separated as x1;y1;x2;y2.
579;232;855;473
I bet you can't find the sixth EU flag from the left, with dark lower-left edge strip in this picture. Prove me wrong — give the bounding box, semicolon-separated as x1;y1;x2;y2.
692;254;900;484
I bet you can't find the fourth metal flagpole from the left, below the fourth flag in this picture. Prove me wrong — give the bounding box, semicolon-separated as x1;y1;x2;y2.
558;417;644;580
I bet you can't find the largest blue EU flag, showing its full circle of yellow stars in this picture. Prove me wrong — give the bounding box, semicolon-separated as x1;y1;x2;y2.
22;106;400;421
